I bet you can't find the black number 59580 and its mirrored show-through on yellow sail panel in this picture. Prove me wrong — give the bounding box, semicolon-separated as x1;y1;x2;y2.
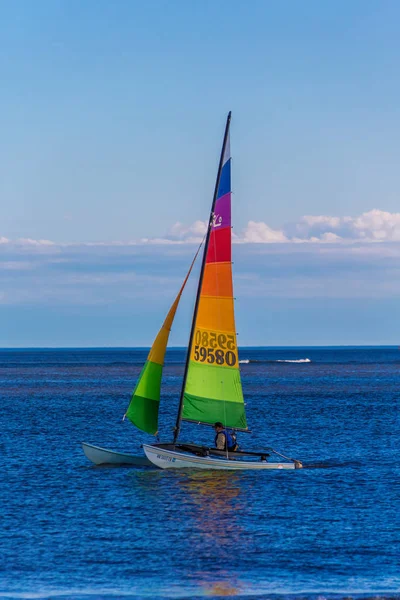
192;329;237;367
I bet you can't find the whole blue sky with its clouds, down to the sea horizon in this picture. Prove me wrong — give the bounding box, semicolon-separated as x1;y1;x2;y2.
0;0;400;347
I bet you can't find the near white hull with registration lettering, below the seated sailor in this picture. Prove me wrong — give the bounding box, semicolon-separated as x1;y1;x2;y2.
143;444;296;471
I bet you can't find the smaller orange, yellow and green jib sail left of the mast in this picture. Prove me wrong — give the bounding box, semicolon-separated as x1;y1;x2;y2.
125;245;201;434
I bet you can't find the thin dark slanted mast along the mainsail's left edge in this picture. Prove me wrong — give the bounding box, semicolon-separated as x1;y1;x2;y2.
173;111;231;444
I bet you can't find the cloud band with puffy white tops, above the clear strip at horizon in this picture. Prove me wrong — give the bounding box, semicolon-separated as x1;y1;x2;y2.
0;210;400;305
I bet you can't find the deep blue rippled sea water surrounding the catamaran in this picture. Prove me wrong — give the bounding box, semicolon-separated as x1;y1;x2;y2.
0;347;400;599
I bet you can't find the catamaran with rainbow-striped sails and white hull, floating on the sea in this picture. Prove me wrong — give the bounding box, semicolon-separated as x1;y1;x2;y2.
126;113;302;470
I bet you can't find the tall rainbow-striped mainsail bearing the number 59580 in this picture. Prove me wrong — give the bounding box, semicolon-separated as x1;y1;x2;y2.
180;113;247;435
